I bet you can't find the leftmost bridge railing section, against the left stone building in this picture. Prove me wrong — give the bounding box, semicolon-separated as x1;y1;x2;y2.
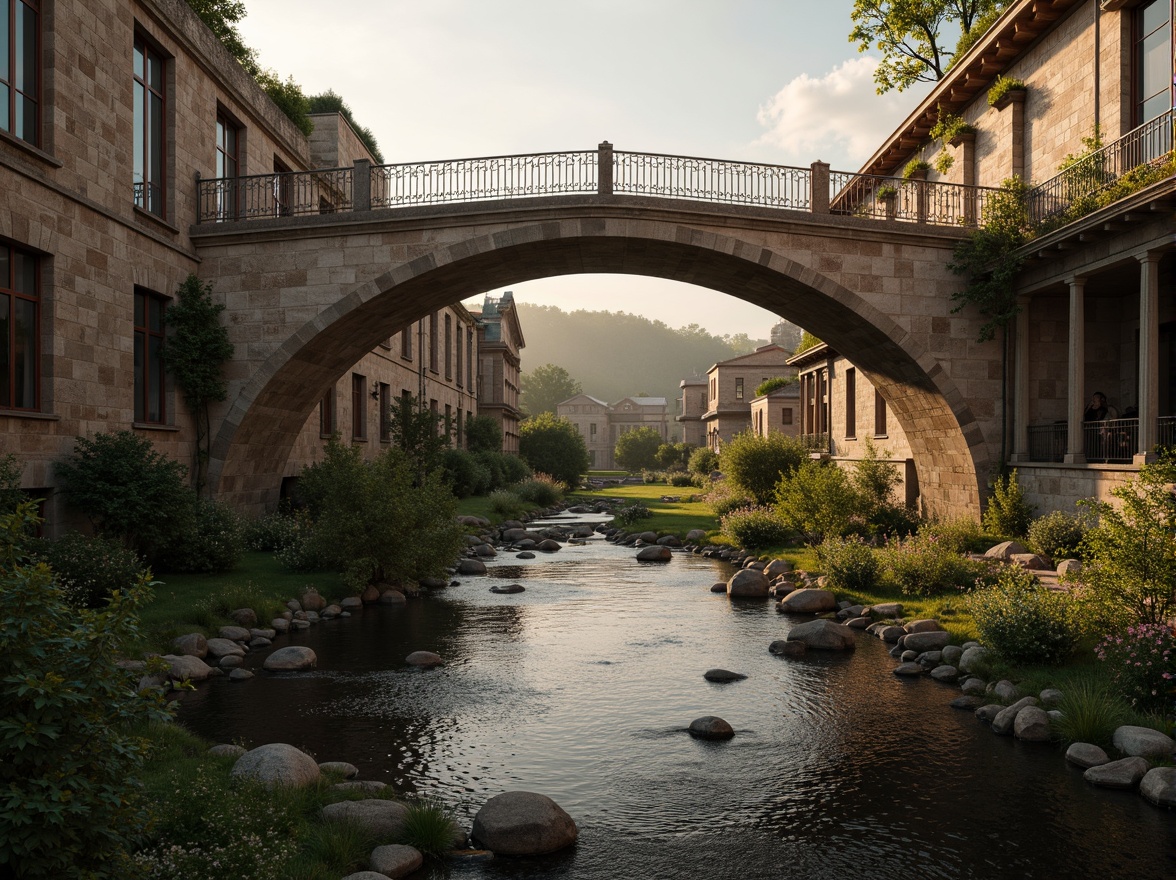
198;168;354;222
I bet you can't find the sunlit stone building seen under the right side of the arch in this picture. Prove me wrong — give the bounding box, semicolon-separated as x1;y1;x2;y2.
788;342;918;508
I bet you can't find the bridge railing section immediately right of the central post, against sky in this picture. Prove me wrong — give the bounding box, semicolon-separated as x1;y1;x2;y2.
613;152;811;211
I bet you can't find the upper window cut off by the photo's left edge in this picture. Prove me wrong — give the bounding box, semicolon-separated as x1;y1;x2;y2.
0;0;41;144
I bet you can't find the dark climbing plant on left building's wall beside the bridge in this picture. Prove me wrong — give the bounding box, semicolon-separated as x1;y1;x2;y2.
162;275;233;494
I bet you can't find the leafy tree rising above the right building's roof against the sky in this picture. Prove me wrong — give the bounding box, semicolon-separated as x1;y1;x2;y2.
849;0;1002;94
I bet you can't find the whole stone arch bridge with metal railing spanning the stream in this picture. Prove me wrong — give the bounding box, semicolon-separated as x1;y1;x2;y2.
191;144;1001;516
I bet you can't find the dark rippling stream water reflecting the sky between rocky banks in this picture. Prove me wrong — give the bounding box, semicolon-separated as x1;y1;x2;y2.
171;527;1176;880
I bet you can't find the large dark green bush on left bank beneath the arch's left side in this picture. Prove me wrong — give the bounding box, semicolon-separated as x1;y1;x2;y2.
299;438;463;589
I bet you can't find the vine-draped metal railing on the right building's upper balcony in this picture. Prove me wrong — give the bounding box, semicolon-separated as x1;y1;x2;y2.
1028;111;1172;226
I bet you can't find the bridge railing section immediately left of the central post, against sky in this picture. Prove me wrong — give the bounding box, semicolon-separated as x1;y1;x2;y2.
370;151;597;208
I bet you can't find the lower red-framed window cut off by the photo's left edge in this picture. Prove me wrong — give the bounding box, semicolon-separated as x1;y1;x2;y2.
0;242;41;409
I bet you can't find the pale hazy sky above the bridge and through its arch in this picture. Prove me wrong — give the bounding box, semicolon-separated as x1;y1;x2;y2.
239;0;927;338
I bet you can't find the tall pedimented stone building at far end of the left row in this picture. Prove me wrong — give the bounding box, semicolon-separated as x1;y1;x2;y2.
475;291;527;455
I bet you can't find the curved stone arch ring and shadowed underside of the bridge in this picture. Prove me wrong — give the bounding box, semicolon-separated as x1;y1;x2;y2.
211;218;989;515
